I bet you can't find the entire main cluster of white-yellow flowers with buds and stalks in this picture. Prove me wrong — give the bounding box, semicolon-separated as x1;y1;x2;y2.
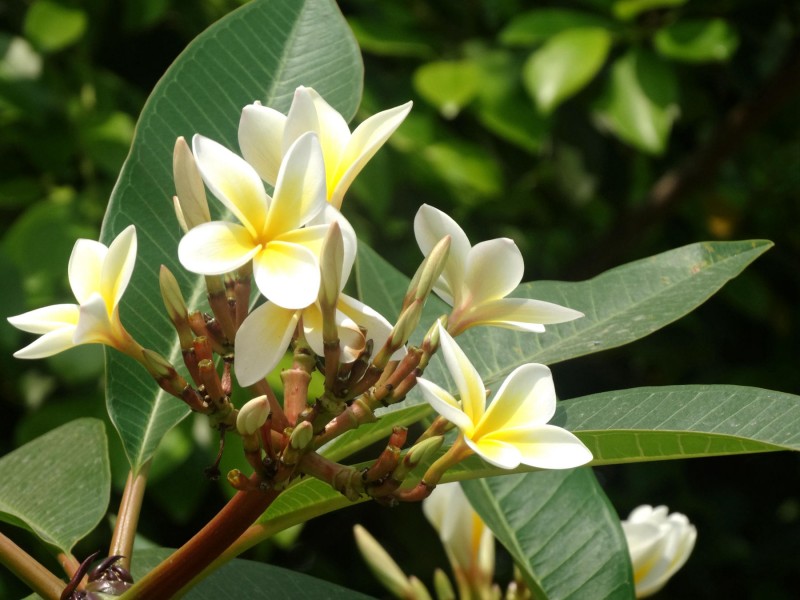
10;87;591;504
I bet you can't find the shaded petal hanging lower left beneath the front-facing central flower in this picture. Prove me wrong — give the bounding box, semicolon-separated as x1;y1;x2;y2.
239;302;299;387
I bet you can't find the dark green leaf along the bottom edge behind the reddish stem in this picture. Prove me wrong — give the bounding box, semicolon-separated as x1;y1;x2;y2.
132;548;370;600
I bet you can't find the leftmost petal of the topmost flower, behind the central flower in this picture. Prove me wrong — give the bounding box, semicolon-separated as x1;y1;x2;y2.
239;103;286;186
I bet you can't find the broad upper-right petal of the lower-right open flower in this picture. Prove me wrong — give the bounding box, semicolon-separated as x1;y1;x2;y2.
475;363;556;438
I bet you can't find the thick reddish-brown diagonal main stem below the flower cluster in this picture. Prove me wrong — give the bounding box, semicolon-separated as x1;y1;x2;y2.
122;489;280;600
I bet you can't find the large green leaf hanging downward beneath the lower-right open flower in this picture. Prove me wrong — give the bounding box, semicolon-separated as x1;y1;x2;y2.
461;468;634;600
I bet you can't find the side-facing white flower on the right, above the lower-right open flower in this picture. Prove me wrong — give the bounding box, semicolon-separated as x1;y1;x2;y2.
414;204;583;335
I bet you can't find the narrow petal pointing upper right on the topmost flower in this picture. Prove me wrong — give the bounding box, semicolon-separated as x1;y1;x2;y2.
326;102;412;208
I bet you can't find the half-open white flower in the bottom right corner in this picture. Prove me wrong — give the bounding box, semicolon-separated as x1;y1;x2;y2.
622;504;697;598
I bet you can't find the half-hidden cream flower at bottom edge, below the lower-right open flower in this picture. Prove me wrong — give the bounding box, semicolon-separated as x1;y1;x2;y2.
422;483;494;598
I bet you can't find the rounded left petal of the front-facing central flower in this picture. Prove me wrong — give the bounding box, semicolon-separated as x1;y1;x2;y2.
178;221;262;275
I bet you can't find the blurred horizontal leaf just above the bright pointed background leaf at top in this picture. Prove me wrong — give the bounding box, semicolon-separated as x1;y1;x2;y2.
500;8;616;46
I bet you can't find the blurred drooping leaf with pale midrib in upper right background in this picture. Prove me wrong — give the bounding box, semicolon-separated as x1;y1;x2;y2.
595;49;678;154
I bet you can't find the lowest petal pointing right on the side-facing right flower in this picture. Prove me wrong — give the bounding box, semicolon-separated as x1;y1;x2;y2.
463;298;583;333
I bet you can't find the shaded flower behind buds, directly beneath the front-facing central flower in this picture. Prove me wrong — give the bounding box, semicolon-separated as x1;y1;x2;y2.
234;214;405;386
